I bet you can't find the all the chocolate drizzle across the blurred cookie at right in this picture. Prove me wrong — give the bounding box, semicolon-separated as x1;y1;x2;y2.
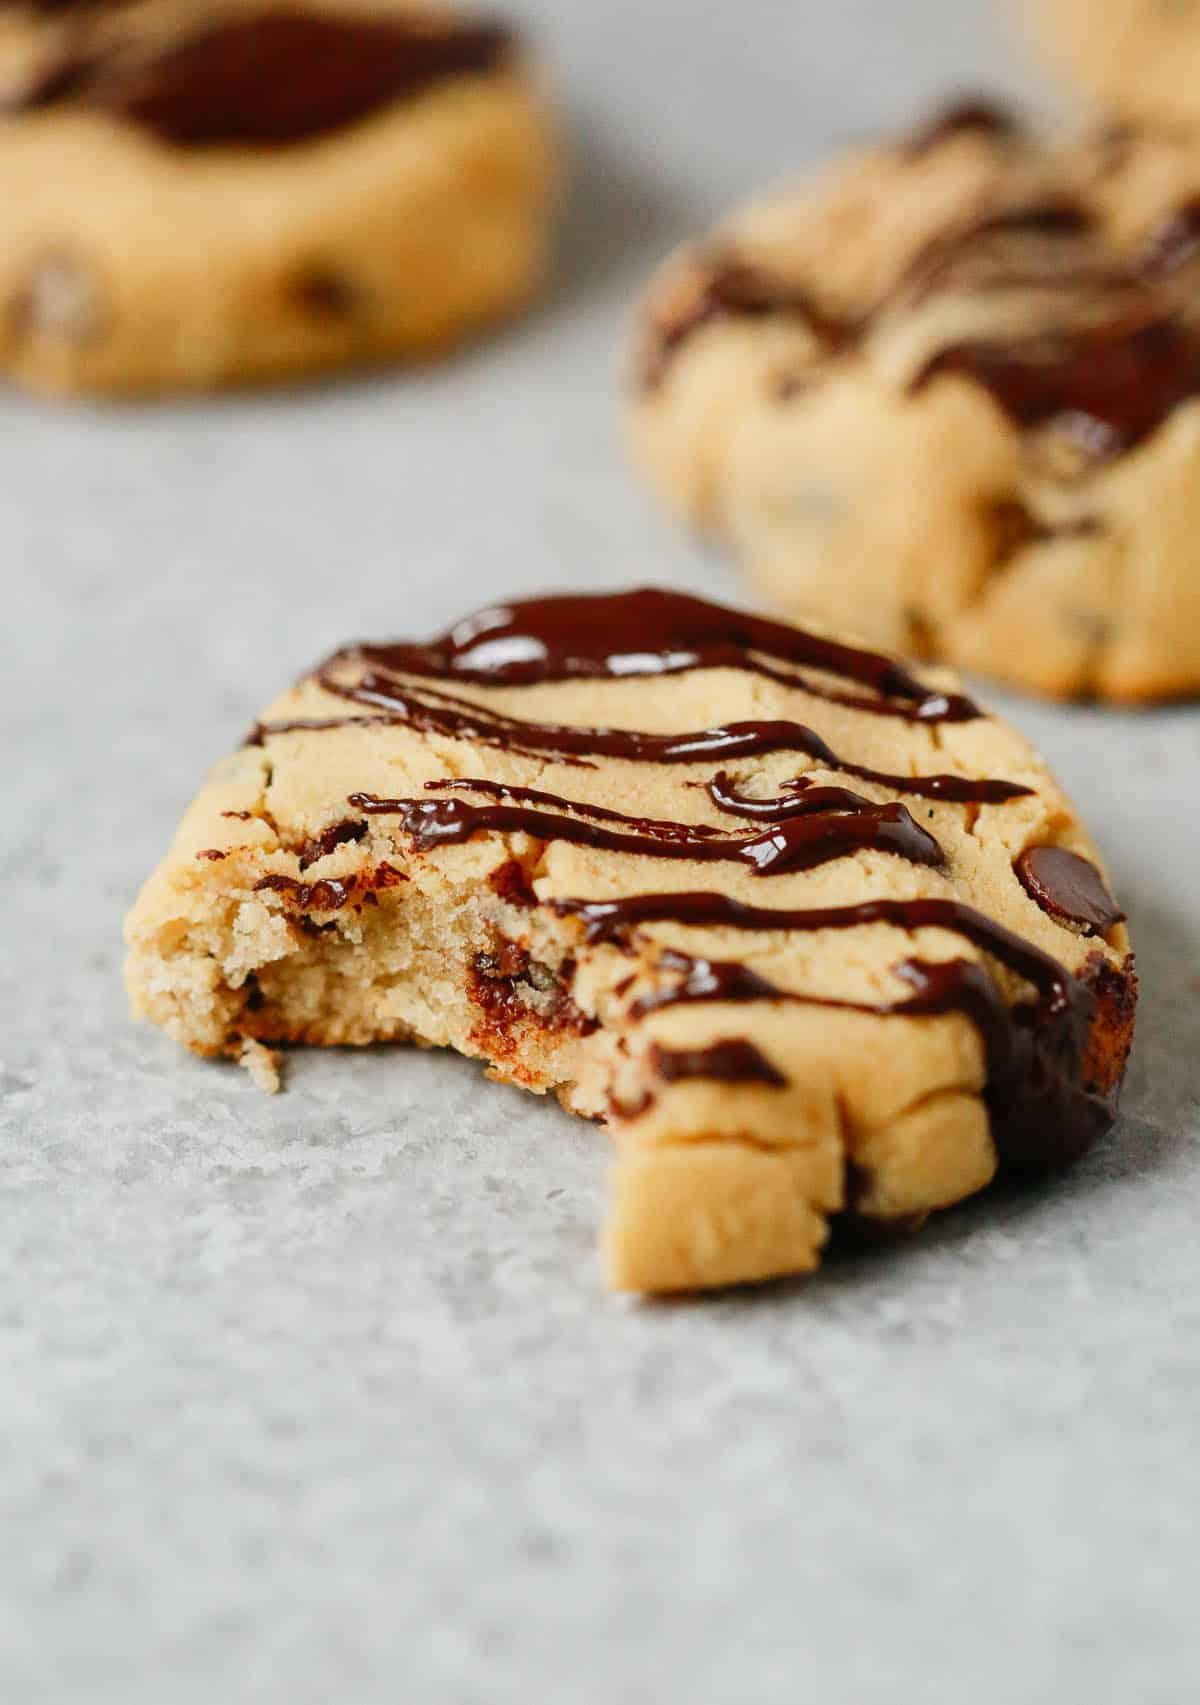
643;101;1200;464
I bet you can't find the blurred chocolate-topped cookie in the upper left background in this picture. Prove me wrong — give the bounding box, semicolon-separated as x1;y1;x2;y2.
0;0;554;392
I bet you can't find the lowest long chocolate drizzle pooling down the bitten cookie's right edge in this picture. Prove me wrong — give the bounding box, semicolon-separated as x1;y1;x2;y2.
549;893;1116;1171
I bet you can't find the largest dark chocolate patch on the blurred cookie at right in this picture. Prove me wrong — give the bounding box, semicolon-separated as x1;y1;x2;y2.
910;317;1200;460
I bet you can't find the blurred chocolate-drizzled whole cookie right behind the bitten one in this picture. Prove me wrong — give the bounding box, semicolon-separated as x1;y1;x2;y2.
631;104;1200;701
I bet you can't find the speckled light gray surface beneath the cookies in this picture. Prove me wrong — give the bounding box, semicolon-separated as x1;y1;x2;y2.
0;0;1200;1705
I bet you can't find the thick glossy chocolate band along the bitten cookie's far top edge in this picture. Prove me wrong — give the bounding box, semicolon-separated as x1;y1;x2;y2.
319;587;980;723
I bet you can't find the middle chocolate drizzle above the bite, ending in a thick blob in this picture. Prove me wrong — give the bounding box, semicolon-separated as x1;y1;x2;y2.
349;783;944;876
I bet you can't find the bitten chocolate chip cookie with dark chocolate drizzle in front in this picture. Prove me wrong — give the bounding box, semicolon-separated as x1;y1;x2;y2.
126;590;1135;1291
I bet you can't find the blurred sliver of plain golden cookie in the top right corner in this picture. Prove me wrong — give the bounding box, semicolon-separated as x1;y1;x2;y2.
1023;0;1200;124
